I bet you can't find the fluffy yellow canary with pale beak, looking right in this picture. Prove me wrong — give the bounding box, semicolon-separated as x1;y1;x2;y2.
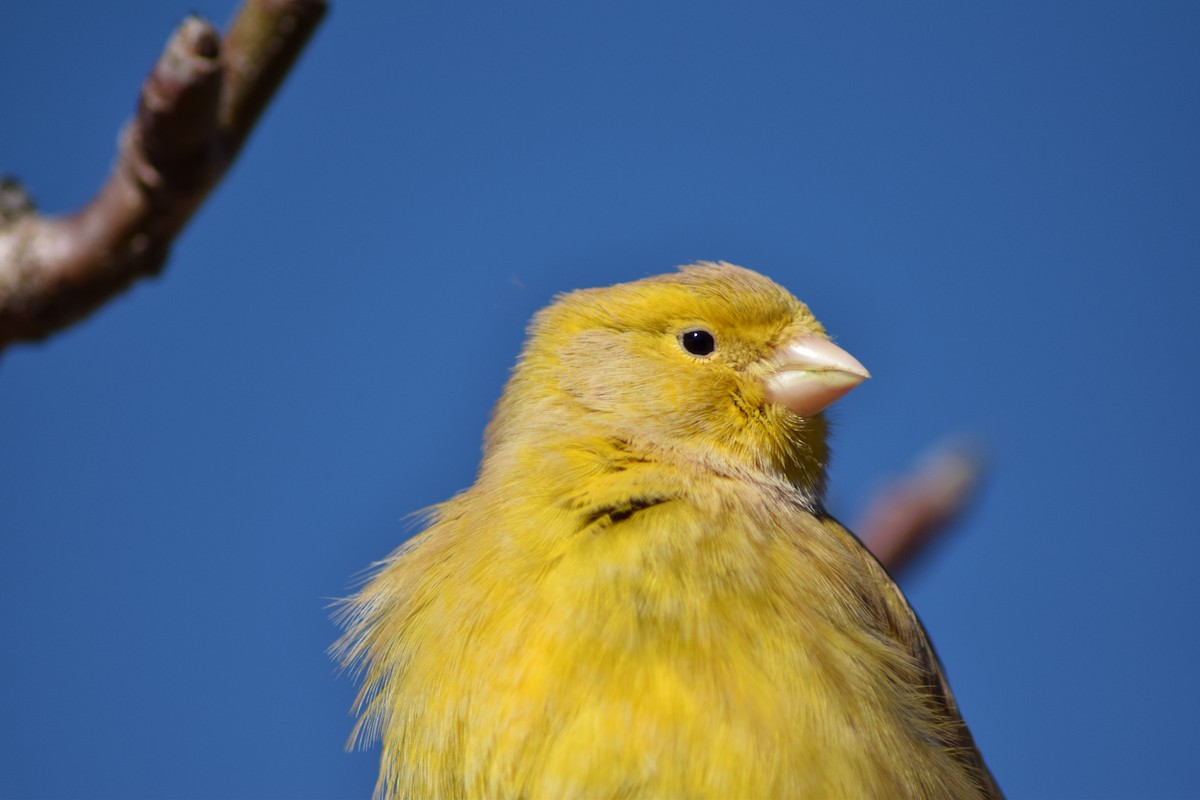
338;263;1001;800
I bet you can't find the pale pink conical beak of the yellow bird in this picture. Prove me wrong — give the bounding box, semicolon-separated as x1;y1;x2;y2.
766;336;871;416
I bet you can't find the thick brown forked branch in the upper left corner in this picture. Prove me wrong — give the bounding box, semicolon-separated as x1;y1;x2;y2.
0;0;326;349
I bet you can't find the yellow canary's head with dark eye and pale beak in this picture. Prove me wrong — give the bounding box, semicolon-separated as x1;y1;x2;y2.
487;263;869;497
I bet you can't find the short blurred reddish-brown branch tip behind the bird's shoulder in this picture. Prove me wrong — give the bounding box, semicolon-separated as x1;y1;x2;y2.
856;441;986;575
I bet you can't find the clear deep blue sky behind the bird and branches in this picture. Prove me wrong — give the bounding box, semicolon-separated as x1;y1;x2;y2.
0;0;1200;798
